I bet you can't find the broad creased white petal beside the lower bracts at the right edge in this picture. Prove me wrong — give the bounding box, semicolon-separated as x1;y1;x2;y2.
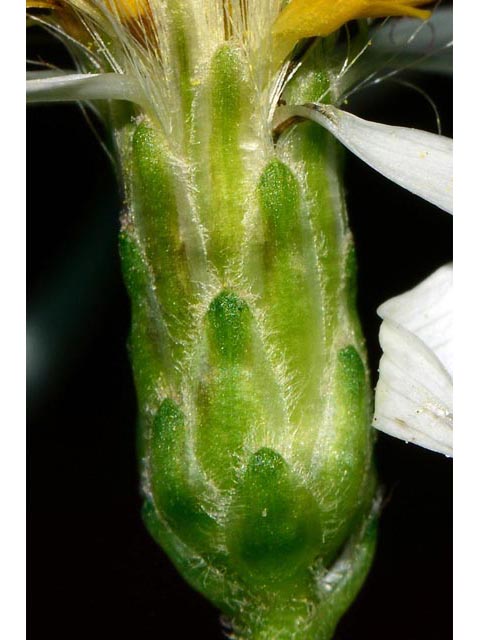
373;265;453;456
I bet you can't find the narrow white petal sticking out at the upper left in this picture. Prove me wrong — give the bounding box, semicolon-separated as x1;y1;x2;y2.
27;71;140;102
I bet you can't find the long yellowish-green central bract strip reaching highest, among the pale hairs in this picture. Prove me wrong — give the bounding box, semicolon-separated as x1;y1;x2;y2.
189;45;255;276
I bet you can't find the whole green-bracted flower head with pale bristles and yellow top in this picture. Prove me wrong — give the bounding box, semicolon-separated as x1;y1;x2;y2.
27;0;451;640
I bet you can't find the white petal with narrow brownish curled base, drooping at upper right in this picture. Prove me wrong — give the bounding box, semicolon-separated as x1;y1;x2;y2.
274;105;453;213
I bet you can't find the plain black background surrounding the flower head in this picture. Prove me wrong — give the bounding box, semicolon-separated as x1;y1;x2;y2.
28;17;452;640
